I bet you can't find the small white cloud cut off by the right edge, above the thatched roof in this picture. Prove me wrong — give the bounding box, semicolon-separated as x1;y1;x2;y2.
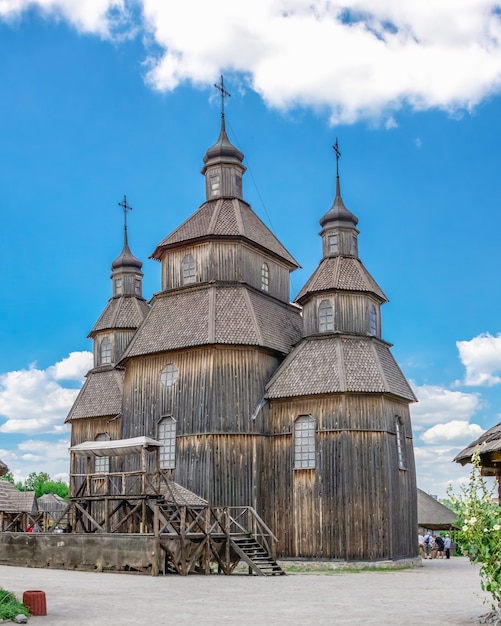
456;333;501;387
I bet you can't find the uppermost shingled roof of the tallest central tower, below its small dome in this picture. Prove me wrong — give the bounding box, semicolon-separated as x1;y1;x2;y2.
150;198;299;268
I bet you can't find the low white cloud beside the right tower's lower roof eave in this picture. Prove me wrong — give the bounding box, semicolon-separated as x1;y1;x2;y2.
411;384;481;430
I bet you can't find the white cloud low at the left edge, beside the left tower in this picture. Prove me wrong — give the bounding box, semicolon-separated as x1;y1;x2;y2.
0;352;92;434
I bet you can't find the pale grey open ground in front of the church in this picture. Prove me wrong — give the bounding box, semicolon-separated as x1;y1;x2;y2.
0;557;489;626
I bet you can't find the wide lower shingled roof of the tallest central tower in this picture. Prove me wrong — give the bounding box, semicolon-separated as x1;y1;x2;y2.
123;284;302;359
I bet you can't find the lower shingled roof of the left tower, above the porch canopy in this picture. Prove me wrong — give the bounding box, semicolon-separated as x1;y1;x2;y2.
65;366;124;422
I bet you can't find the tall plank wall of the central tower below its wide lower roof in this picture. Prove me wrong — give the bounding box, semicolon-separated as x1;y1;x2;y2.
120;346;278;505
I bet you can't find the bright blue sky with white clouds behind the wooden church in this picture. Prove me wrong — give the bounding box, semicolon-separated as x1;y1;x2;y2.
0;0;501;496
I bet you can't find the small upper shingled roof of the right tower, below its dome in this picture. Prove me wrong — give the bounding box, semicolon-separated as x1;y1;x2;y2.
295;256;388;302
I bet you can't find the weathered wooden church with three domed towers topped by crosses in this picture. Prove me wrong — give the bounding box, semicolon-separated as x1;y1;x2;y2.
67;92;417;561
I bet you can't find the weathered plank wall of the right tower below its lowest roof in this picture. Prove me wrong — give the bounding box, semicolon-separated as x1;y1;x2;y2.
262;395;417;560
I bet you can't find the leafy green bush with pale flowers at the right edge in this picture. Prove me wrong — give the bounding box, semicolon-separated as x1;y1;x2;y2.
447;450;501;610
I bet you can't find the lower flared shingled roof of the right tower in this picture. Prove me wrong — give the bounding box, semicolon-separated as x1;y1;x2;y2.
266;335;416;402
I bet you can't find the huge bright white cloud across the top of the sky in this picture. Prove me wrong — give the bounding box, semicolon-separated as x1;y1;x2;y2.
0;0;501;126
